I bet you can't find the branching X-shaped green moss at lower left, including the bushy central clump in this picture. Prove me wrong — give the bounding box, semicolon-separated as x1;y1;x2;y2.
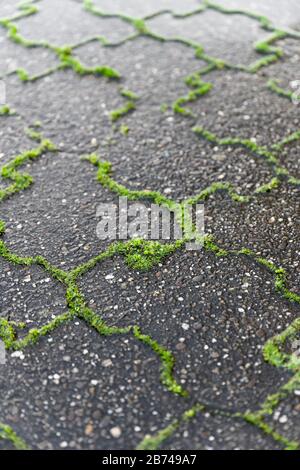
0;229;184;395
